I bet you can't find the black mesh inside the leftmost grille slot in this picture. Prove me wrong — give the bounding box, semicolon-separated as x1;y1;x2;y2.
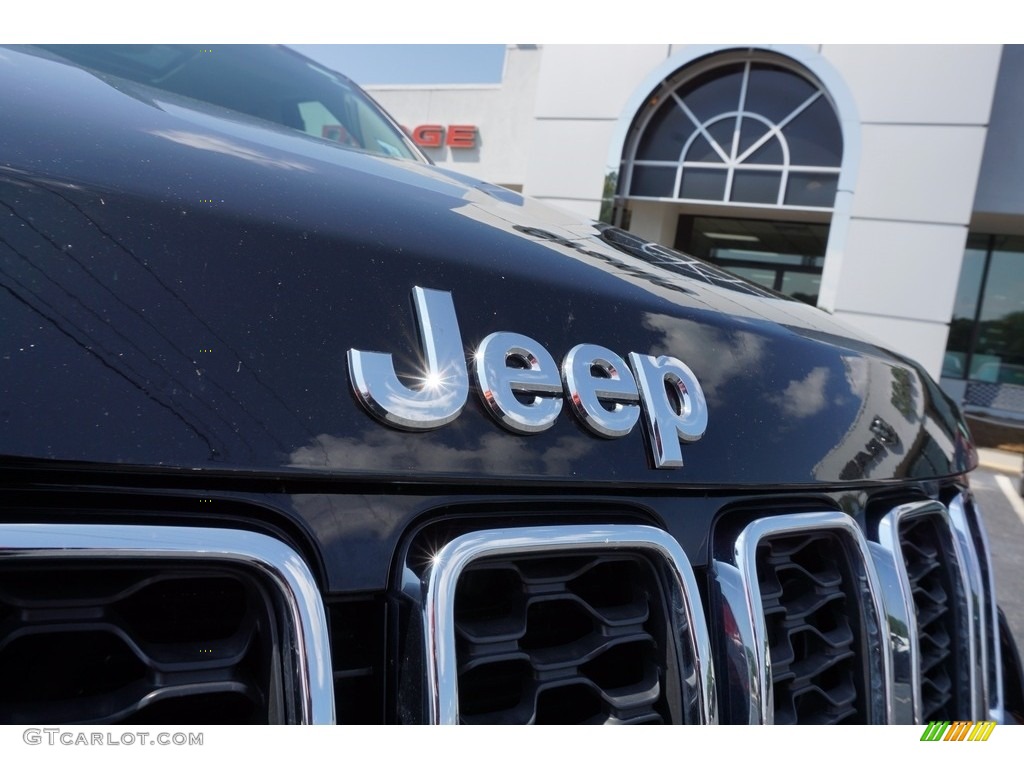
0;561;283;724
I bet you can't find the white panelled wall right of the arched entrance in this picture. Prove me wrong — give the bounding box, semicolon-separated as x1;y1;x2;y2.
820;45;1000;379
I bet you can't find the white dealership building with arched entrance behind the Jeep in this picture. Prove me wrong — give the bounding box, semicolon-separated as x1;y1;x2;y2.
367;45;1024;419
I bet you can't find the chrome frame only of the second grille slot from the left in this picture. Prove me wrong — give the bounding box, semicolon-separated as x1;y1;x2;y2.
406;525;718;724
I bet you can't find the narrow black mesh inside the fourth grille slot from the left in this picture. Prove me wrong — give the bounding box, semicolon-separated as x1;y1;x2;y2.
899;515;970;722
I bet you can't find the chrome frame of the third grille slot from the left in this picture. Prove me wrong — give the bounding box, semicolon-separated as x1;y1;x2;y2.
713;512;892;724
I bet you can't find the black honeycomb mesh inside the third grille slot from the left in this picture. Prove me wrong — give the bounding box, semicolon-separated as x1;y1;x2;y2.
757;532;867;725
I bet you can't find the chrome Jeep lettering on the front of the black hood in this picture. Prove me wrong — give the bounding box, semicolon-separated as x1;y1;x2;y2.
348;287;708;469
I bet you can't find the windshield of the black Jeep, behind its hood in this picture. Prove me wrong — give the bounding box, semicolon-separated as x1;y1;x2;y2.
40;45;424;161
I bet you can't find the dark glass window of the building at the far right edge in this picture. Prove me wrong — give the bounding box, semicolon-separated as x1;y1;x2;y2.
942;234;1024;385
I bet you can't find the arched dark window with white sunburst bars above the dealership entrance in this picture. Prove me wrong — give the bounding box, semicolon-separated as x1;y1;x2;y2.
621;53;843;211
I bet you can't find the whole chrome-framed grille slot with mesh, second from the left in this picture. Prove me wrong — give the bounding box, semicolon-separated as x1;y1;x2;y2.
399;525;717;723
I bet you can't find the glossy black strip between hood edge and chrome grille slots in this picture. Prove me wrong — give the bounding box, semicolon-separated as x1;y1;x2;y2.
0;475;950;594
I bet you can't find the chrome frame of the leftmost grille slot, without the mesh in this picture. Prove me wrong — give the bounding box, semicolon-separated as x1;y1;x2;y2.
0;523;335;725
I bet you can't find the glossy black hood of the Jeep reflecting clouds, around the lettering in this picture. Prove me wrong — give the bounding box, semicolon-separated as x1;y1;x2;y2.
0;51;974;487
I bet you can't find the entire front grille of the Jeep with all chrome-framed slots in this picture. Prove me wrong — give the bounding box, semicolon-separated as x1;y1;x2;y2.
0;495;1002;724
